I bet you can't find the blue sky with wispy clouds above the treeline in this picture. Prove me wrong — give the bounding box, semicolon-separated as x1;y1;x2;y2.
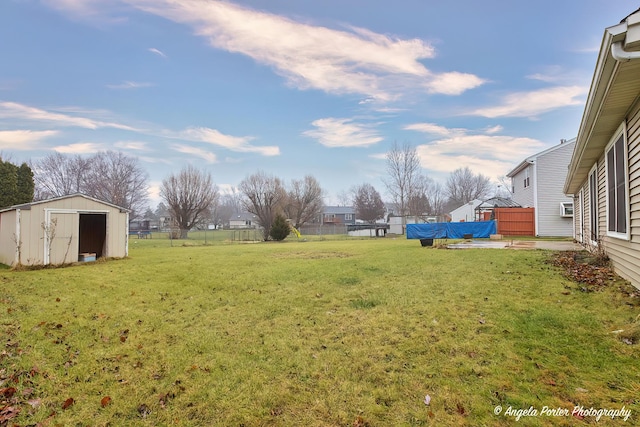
0;0;640;207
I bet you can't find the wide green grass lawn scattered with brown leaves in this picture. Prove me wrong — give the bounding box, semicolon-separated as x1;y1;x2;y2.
0;238;640;427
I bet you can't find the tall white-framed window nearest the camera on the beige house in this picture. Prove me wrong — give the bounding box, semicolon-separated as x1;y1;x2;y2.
606;126;628;239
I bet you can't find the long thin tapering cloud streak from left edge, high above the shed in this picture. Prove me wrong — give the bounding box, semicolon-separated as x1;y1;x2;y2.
0;102;136;131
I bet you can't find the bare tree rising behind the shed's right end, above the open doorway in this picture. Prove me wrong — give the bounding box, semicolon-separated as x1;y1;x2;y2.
81;151;149;218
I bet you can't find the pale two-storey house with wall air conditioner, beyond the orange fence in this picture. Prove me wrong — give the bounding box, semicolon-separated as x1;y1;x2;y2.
507;138;576;237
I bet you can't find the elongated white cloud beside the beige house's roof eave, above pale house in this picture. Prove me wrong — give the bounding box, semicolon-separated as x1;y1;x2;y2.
468;86;588;118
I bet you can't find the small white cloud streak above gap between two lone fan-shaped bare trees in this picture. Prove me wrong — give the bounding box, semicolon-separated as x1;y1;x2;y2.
170;127;280;156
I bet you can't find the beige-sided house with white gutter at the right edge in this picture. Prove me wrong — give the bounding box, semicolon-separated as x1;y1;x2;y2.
564;9;640;288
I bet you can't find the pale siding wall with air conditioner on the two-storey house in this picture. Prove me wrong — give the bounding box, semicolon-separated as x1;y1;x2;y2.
536;142;575;237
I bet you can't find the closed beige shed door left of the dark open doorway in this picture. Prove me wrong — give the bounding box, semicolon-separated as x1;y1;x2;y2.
45;212;78;265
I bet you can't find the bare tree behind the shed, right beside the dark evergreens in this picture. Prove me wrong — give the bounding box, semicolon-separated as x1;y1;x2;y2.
31;152;91;200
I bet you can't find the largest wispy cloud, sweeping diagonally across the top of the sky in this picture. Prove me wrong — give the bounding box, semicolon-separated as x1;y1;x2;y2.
90;0;484;101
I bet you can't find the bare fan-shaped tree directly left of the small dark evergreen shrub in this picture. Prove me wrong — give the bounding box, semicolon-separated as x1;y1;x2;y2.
239;171;286;241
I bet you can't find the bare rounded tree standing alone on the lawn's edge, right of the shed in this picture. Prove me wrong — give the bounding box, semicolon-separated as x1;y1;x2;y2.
160;165;218;239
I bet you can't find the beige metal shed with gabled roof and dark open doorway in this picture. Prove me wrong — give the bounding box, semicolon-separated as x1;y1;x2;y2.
0;194;129;265
